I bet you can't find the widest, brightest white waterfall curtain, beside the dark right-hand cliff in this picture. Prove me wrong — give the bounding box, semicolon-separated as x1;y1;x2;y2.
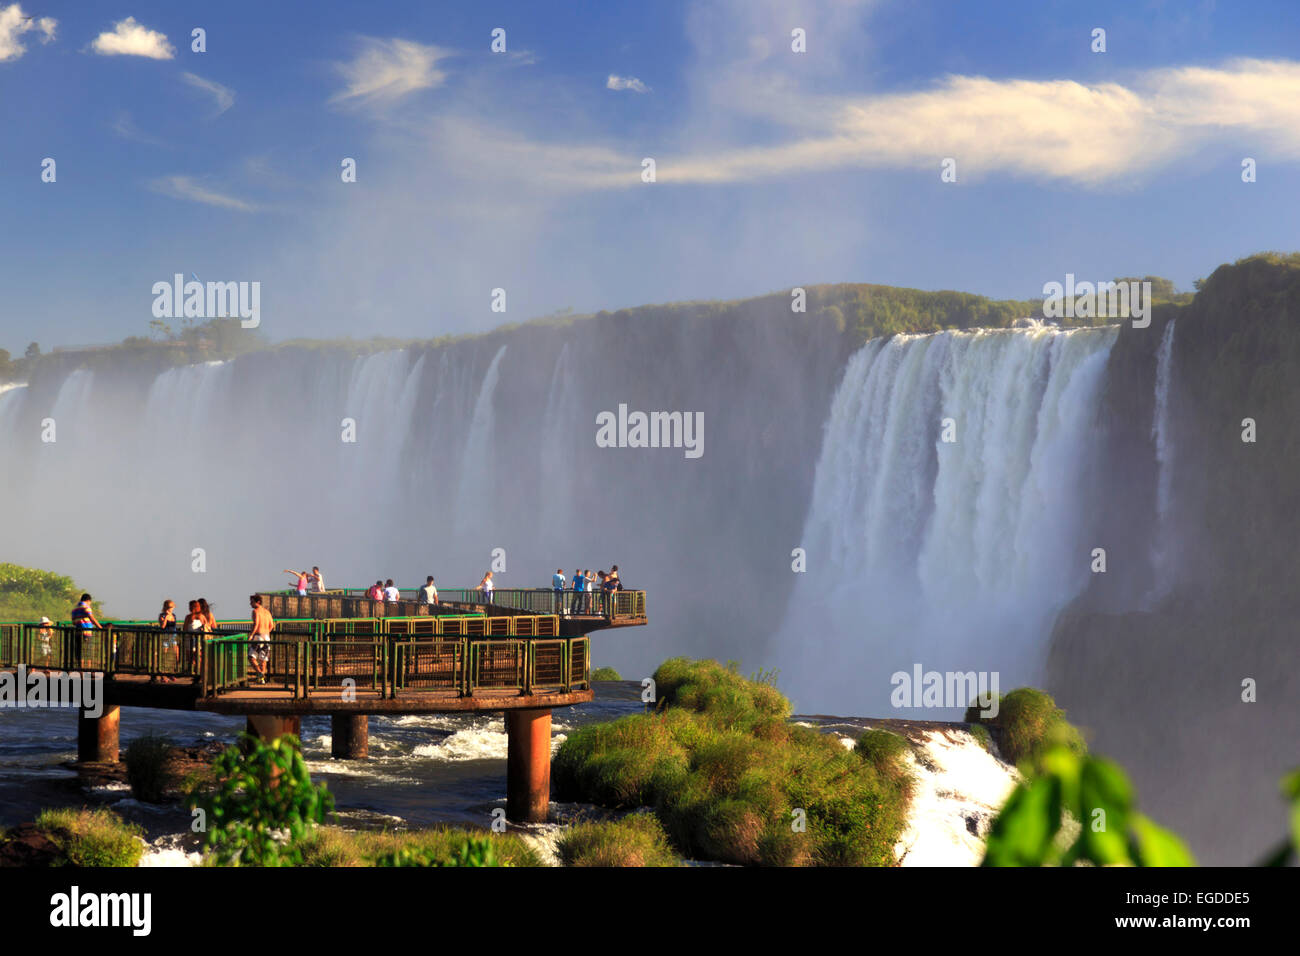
772;326;1117;717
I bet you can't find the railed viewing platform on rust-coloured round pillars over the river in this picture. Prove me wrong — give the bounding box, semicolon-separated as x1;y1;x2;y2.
0;588;646;822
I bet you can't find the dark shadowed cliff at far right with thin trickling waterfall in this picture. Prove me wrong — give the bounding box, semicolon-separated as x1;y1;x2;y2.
1048;258;1300;864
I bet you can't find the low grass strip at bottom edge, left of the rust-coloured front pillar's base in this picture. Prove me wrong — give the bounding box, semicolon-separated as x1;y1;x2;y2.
298;826;543;866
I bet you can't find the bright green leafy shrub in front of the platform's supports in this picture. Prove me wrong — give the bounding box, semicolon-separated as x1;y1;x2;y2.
199;734;334;866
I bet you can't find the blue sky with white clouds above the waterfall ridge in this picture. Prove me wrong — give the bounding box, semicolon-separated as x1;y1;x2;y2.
0;0;1300;352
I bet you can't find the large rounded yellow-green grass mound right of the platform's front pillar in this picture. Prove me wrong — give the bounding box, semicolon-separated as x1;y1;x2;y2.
551;658;911;866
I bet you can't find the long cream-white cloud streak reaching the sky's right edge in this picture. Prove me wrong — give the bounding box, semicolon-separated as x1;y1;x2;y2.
658;60;1300;185
